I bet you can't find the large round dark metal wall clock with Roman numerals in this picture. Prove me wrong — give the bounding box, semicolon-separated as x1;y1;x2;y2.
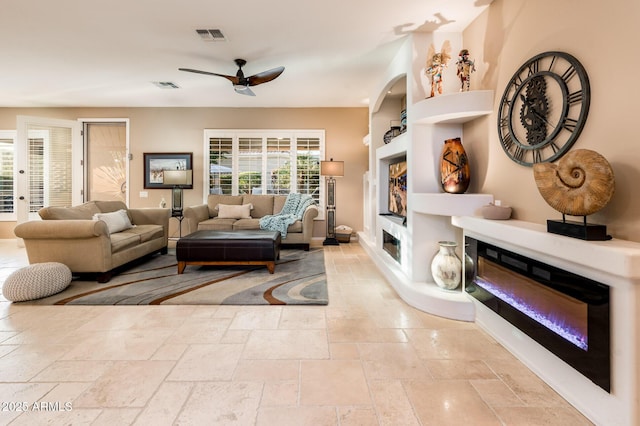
498;52;591;166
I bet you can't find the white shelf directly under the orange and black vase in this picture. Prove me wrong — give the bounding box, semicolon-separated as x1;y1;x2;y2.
407;193;493;216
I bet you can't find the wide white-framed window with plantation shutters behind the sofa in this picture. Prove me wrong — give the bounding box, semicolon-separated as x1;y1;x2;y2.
205;129;324;219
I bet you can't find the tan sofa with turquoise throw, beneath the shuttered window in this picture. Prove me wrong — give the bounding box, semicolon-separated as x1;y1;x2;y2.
182;194;318;250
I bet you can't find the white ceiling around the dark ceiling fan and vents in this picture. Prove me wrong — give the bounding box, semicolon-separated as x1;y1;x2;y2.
0;0;491;107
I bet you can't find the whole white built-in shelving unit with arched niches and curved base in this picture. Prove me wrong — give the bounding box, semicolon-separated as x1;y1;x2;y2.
359;33;494;321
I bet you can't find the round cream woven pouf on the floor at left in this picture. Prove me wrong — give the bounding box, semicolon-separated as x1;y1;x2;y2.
2;262;71;302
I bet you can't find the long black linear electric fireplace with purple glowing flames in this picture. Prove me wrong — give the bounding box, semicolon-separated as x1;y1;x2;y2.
465;236;611;392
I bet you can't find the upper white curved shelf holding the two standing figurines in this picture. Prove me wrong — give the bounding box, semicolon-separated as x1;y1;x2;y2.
412;90;493;124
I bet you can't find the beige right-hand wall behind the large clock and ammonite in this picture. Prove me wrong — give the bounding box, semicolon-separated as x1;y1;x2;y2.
463;0;640;242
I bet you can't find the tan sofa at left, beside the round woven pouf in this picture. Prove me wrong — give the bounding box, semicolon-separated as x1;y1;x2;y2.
14;201;171;282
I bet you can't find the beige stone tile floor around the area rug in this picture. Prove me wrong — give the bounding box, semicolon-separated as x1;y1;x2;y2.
0;241;591;426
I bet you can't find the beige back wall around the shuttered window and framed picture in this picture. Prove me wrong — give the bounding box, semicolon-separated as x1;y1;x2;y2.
0;108;368;238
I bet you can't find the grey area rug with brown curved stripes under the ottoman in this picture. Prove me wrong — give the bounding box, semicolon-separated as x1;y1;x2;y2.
24;248;328;305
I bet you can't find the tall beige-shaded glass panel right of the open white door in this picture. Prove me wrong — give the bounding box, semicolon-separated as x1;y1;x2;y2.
85;123;127;203
